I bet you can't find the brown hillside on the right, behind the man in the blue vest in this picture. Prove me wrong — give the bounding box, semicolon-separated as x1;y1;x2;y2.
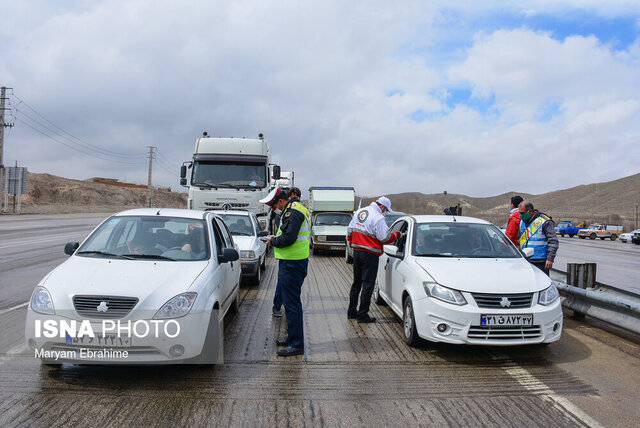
362;174;640;230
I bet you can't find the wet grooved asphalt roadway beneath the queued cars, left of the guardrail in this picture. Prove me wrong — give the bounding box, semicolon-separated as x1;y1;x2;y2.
0;217;640;427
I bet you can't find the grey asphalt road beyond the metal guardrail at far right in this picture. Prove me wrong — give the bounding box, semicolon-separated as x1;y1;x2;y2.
553;237;640;295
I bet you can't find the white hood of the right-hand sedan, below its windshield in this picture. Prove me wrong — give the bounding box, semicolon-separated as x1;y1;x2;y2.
415;257;550;293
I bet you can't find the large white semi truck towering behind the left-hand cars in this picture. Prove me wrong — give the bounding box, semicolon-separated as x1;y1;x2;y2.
180;132;280;230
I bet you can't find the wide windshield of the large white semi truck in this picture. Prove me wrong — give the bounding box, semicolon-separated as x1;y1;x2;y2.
191;161;267;189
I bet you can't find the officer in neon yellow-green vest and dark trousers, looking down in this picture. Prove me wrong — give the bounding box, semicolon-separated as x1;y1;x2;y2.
260;189;311;357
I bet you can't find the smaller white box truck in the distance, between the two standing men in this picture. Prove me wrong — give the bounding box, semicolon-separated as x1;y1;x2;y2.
309;187;355;254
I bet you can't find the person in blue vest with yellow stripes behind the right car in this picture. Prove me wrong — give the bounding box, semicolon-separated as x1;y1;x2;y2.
518;201;558;275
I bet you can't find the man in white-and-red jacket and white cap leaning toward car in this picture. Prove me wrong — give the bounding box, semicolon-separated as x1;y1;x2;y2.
347;196;402;323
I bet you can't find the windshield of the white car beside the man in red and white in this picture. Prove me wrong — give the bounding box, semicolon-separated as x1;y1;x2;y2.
412;222;522;259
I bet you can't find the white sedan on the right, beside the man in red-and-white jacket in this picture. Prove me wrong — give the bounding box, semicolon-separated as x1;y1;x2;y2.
374;215;562;345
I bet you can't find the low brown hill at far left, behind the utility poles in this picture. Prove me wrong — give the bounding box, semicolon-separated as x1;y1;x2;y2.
6;172;187;214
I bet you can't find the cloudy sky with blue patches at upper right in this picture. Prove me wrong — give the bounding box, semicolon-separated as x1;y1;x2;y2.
0;0;640;196
